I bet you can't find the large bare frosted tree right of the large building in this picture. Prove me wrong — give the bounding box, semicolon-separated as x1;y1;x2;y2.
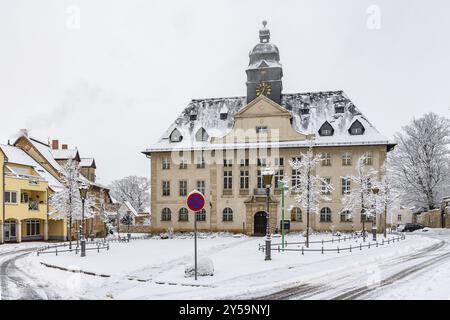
389;113;450;210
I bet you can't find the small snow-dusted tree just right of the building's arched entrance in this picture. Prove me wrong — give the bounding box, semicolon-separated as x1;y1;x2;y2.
289;142;334;247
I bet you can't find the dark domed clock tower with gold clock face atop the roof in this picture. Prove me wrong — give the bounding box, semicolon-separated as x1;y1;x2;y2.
246;21;283;104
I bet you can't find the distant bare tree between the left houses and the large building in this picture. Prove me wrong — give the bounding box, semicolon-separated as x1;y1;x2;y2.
109;176;150;211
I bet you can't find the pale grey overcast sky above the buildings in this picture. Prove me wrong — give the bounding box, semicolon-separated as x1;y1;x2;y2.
0;0;450;184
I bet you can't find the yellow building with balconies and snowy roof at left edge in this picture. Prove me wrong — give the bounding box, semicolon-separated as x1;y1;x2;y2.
0;145;66;243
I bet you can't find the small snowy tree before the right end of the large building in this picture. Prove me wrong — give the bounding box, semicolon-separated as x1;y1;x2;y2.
342;154;378;241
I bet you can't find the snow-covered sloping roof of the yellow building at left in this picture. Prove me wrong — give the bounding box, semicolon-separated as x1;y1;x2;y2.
0;145;63;191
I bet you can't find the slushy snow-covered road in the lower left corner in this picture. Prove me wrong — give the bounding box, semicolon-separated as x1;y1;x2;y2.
0;246;57;300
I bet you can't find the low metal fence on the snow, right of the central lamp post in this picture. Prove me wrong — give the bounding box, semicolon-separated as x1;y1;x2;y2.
258;234;406;255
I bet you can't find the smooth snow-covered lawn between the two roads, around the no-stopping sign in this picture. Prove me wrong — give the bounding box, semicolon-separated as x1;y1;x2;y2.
17;230;446;299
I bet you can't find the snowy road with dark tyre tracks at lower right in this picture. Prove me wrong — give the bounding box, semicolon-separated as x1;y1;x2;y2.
255;231;450;300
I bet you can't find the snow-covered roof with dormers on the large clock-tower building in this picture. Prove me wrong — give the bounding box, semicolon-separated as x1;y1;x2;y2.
144;91;393;153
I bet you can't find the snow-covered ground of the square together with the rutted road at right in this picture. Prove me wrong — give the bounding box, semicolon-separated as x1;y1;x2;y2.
12;230;450;299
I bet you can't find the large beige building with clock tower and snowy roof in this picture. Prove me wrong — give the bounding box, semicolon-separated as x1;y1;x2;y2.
143;23;394;235
